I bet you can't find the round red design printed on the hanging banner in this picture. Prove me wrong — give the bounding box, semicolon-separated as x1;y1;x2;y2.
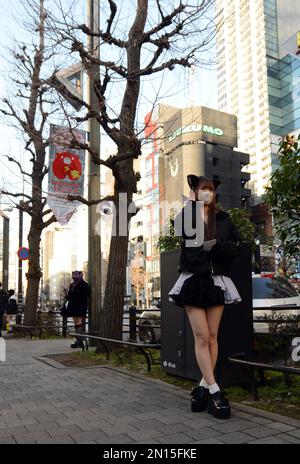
52;151;82;180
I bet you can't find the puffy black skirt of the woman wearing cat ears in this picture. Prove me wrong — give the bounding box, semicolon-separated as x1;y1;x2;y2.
169;273;225;308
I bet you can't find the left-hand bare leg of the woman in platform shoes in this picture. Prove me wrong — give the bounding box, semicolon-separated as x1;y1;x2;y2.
185;306;215;385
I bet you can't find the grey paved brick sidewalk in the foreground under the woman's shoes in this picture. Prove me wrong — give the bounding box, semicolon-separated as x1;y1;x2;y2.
0;339;300;444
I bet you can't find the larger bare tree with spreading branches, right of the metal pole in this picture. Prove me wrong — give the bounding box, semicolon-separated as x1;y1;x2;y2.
48;0;215;338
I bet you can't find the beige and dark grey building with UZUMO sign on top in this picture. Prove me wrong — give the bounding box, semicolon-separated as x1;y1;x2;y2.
158;105;250;209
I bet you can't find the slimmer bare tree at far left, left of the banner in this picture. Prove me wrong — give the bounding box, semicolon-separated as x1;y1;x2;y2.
0;0;56;325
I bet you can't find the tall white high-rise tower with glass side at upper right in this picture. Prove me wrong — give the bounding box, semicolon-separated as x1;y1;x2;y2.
216;0;300;204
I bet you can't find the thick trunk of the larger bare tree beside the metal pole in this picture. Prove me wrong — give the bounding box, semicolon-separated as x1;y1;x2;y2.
96;0;148;340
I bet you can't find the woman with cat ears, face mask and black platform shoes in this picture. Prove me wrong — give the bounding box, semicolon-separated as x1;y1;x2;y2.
169;175;241;419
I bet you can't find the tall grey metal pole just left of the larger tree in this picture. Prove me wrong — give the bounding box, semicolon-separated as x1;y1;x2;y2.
87;0;101;332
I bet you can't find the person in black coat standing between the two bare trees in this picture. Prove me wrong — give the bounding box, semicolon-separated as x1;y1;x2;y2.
65;271;89;348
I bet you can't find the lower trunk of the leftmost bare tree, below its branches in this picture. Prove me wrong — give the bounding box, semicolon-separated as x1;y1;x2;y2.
24;220;42;325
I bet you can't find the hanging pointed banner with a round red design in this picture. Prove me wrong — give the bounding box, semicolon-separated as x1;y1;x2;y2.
47;125;85;225
